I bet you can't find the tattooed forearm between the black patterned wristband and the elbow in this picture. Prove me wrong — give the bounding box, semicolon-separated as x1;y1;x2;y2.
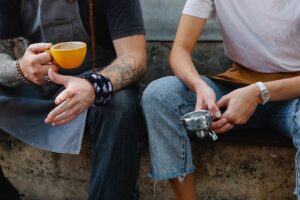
99;55;146;91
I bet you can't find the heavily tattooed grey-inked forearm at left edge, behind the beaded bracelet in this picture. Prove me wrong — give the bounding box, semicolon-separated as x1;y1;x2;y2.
0;39;22;86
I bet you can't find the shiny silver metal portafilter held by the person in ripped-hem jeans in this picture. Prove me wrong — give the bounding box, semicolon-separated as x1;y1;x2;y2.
182;110;218;141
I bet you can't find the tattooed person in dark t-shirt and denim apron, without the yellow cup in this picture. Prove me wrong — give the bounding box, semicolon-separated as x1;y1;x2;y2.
0;0;146;200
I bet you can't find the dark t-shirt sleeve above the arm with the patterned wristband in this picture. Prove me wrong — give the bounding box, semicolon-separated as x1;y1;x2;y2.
105;0;145;40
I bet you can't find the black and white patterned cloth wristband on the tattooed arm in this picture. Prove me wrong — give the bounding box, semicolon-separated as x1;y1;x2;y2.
83;73;113;106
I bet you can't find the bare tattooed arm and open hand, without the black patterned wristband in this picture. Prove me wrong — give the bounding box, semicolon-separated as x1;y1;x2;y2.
45;35;146;125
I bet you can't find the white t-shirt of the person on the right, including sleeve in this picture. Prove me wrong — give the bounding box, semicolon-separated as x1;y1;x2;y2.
183;0;300;73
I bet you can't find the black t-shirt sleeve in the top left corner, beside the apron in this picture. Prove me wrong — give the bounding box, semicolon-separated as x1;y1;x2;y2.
0;0;21;39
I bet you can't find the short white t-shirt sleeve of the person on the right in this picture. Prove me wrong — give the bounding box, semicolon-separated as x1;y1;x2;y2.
182;0;215;19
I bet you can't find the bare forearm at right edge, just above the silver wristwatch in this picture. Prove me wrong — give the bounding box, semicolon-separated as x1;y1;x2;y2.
265;76;300;101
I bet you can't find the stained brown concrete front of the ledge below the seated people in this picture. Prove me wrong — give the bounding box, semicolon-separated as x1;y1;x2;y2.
0;131;295;200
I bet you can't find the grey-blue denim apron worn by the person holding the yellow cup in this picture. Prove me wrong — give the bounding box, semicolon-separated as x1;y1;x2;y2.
0;0;111;154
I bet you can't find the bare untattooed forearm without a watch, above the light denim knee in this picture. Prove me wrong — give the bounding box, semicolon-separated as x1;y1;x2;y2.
170;47;204;91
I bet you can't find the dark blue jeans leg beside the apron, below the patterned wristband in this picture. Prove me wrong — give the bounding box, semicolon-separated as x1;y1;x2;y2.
87;89;141;200
